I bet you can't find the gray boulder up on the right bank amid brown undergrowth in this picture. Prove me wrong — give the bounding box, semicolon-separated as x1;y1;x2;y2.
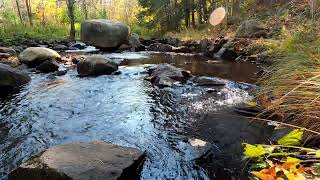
236;19;268;38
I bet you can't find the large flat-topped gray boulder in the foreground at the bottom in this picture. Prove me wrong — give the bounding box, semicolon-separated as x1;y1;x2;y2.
9;141;145;180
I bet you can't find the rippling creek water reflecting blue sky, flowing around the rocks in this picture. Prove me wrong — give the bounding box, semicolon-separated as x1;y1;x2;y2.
0;52;270;179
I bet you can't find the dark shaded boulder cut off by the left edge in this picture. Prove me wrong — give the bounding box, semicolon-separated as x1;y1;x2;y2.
0;63;31;88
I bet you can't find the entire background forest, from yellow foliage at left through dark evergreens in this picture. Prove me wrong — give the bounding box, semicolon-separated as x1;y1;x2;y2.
0;0;317;39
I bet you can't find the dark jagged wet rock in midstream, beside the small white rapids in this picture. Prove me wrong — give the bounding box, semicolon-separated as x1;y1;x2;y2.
148;64;190;87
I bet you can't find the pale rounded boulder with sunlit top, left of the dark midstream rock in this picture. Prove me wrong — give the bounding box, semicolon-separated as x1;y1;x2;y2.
18;47;61;67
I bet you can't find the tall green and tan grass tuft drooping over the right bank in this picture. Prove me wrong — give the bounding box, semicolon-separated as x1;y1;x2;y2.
258;21;320;132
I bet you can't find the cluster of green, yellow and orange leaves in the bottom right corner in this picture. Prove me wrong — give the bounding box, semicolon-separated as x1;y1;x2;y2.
244;129;320;180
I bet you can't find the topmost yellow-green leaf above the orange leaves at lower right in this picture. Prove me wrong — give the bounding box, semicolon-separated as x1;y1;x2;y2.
278;129;304;146
